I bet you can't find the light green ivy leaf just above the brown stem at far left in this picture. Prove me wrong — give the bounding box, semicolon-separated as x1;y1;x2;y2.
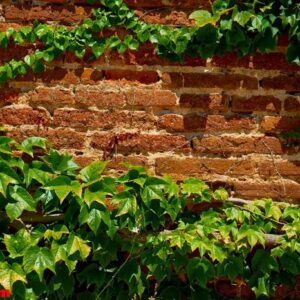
5;186;36;221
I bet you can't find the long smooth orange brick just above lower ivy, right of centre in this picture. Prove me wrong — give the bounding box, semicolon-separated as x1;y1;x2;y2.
155;157;255;178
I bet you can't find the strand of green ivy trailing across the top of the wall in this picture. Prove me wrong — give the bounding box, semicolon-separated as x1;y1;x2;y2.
0;0;300;83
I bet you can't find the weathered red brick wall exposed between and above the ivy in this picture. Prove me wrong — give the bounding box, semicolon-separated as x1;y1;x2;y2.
0;0;300;202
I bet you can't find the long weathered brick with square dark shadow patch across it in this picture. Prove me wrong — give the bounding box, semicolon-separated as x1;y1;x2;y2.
159;114;256;132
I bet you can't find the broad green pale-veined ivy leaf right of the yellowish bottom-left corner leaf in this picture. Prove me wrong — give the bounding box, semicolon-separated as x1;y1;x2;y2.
23;246;55;281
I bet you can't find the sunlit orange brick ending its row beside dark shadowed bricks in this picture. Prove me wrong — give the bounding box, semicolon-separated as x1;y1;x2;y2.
126;89;177;107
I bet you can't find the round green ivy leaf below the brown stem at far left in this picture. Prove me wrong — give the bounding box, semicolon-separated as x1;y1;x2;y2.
4;229;34;258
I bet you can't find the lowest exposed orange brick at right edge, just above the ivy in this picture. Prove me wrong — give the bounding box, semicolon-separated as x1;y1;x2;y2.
233;180;300;203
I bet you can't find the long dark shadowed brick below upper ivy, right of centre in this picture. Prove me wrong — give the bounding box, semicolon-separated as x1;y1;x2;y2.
162;73;258;90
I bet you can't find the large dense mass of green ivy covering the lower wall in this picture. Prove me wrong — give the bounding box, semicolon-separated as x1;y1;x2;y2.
0;137;300;299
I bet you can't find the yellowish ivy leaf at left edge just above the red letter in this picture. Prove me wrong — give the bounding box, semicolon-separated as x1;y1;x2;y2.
0;262;27;291
